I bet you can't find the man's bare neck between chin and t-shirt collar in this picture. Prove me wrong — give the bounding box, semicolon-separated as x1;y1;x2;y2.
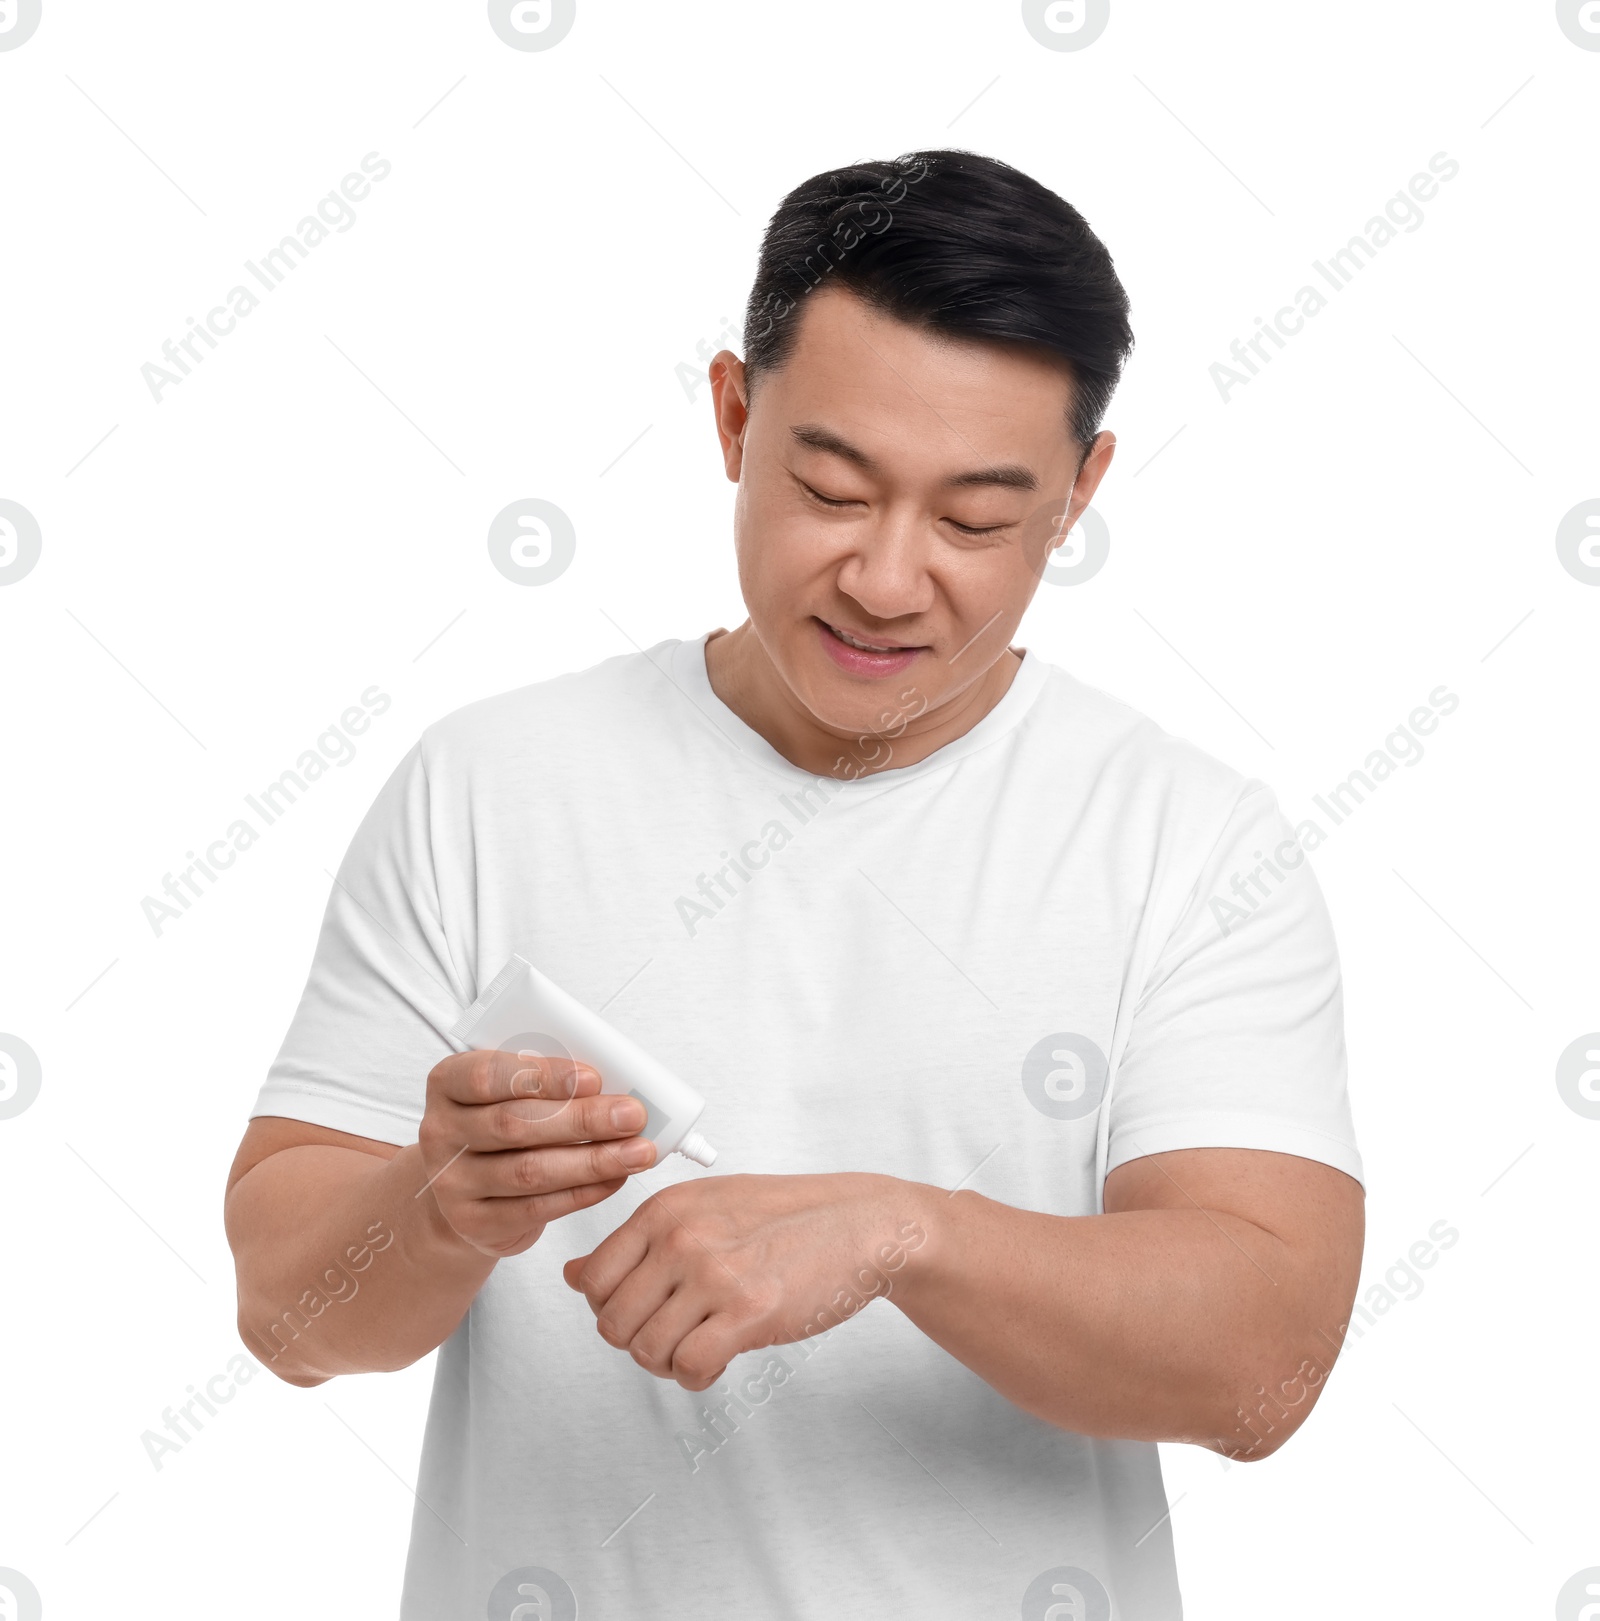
705;619;1021;778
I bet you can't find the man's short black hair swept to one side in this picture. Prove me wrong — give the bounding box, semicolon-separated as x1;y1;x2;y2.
744;149;1133;465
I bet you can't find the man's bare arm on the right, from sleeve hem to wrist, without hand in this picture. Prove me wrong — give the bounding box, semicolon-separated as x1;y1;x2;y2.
890;1148;1365;1461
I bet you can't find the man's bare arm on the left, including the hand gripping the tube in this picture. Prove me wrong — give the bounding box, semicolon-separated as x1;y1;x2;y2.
224;1052;655;1384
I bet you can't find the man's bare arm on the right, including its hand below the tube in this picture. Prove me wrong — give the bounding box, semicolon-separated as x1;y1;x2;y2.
566;1148;1363;1459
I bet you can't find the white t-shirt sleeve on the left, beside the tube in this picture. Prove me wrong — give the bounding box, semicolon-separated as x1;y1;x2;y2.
251;739;472;1146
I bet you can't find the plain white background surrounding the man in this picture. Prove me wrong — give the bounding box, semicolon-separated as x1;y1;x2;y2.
0;0;1600;1621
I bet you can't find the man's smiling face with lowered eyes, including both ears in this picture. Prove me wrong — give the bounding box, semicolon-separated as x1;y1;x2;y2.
712;287;1114;736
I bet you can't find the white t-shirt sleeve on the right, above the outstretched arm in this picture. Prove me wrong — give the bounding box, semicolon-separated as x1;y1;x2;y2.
1106;783;1363;1182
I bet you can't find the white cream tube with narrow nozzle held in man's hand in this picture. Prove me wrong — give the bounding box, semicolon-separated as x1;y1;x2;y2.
451;956;717;1165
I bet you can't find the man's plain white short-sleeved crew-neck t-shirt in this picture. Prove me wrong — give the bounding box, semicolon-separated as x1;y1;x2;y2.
253;637;1362;1621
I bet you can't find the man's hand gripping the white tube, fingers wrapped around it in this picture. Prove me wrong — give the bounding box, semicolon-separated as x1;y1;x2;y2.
417;1050;657;1258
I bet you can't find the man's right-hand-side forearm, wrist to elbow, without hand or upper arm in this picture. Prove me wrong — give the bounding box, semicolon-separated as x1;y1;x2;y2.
890;1188;1339;1457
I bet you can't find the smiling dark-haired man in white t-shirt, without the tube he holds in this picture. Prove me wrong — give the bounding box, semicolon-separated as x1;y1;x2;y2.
227;152;1362;1621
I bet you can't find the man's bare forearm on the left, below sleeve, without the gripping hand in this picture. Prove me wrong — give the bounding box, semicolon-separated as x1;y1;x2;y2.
225;1144;494;1384
